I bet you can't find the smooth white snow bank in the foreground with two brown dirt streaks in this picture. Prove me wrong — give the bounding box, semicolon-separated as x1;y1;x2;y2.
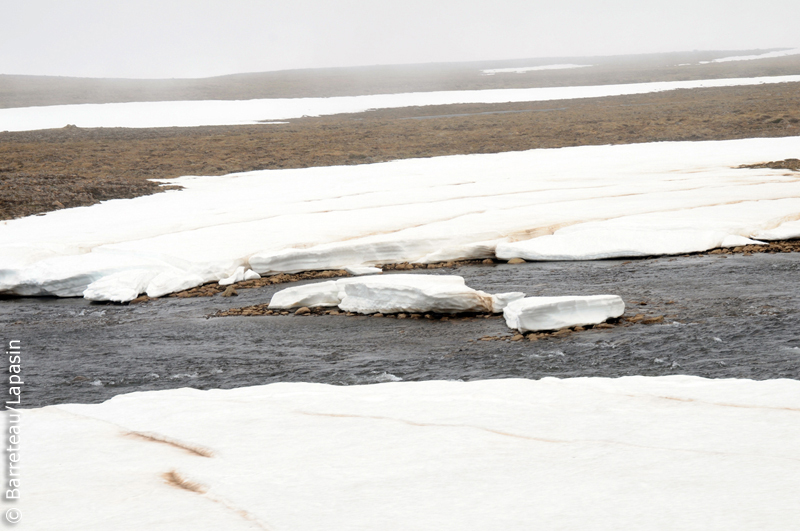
17;376;800;531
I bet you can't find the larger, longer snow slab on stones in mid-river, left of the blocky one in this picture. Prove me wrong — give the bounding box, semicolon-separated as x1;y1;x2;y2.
269;274;525;314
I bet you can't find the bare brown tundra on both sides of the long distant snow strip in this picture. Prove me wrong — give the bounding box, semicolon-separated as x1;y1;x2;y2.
0;52;800;219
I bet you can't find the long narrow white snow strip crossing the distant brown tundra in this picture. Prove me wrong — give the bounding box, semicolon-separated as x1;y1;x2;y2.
0;75;800;131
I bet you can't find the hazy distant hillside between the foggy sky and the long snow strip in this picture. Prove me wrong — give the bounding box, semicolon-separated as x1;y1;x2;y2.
0;50;800;108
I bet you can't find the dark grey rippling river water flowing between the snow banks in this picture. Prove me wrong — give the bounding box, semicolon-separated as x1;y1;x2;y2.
0;253;800;407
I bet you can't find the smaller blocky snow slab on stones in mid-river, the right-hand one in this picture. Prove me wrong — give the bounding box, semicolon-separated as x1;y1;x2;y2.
503;295;625;332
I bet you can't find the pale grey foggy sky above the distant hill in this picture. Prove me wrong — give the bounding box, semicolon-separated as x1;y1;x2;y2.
0;0;800;78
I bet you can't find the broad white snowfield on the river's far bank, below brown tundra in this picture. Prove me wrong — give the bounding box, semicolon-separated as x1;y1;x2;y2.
0;137;800;301
